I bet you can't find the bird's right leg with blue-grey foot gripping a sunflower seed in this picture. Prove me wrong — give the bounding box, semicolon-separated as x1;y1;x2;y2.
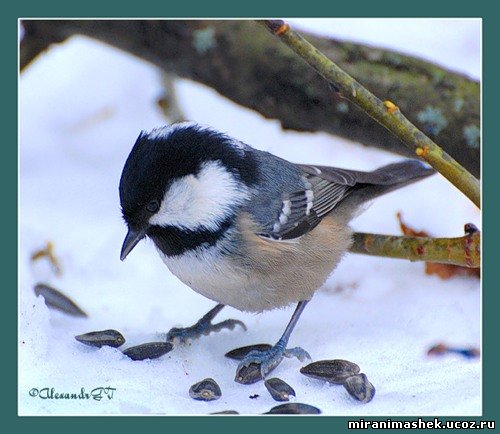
235;300;311;384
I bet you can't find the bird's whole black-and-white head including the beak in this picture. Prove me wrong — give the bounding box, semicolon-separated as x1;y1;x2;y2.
119;123;256;260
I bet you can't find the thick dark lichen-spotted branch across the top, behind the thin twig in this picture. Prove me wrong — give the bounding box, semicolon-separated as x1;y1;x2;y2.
21;20;480;176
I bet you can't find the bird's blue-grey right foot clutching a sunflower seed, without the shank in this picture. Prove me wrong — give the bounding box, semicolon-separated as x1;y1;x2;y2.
234;341;311;384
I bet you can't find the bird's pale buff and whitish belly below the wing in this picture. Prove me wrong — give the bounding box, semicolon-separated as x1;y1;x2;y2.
154;217;351;312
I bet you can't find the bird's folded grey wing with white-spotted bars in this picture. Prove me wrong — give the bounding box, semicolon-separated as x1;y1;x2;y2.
259;164;358;240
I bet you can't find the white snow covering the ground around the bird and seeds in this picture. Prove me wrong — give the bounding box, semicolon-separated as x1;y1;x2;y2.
19;20;481;416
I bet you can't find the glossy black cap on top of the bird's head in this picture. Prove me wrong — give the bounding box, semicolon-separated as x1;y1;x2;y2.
119;123;257;229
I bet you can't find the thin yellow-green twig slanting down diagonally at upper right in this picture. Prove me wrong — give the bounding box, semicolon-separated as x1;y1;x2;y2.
262;20;481;207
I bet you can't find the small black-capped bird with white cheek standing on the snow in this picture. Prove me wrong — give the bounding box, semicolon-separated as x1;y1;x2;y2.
119;122;435;381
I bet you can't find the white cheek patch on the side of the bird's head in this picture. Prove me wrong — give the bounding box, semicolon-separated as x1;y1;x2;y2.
149;161;248;231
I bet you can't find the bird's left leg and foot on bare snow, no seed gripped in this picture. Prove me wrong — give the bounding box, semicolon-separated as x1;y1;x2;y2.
167;304;247;344
